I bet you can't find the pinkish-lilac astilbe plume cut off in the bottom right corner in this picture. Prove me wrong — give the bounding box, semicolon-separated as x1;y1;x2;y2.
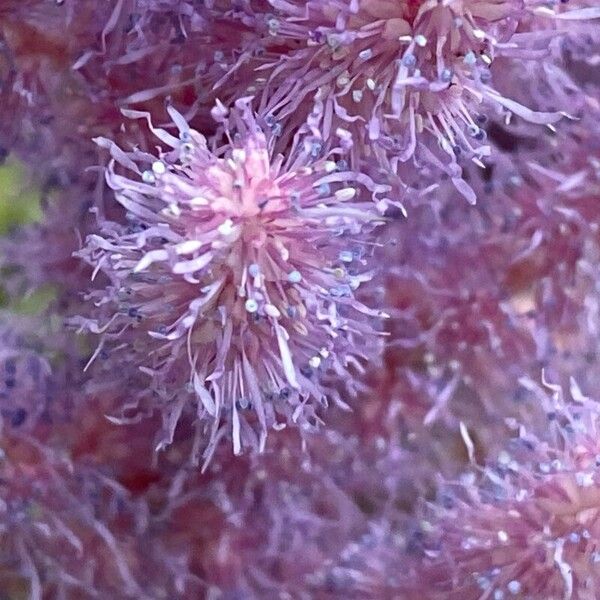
416;378;600;600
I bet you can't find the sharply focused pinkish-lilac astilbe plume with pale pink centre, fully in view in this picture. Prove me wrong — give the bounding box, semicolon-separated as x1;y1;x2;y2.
79;101;383;464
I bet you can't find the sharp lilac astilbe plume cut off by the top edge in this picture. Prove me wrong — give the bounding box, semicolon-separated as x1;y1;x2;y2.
216;0;600;201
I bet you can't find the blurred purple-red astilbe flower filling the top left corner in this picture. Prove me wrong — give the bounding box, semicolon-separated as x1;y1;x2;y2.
0;0;257;186
